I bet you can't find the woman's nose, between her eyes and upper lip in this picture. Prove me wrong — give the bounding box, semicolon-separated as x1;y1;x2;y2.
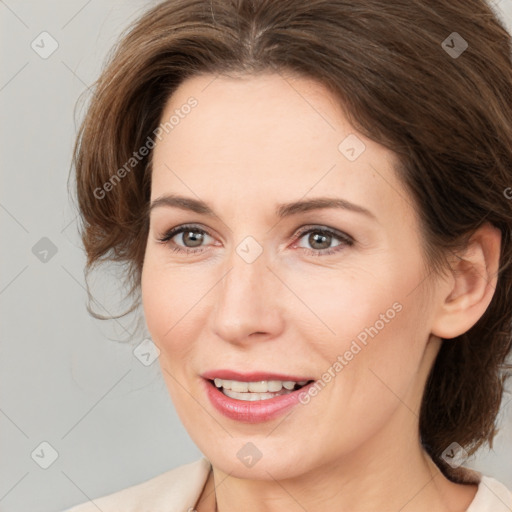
212;247;284;344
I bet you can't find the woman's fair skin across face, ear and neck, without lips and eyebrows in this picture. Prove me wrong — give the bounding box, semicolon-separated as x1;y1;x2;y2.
141;74;500;512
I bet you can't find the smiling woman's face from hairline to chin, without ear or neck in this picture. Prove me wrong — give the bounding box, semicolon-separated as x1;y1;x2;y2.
142;74;438;479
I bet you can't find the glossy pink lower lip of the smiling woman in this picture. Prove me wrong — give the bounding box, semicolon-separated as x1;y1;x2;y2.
203;379;314;423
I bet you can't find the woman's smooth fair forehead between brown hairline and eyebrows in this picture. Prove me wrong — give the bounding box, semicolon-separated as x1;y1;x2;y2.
152;74;407;224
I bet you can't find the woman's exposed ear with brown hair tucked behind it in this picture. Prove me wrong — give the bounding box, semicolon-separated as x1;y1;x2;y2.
432;222;501;339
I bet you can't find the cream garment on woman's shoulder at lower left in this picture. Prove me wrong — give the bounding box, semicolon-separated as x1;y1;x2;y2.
64;457;211;512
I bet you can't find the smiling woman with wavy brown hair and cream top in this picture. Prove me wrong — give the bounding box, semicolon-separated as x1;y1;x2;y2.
64;0;512;512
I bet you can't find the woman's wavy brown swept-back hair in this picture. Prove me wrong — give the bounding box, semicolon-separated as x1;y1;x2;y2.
70;0;512;481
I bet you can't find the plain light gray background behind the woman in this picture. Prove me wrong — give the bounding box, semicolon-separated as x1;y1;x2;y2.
0;0;512;512
